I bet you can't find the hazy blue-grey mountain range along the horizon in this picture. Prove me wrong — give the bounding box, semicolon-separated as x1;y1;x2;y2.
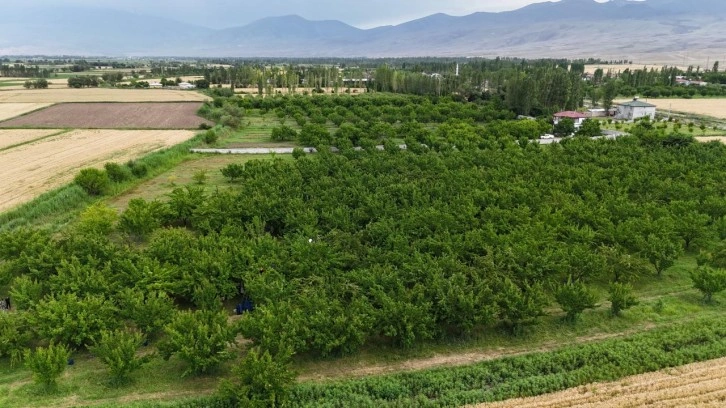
0;0;726;63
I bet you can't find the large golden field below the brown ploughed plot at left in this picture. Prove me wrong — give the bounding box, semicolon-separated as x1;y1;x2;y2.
0;130;194;211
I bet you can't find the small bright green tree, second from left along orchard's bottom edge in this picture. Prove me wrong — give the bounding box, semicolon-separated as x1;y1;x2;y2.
90;330;150;385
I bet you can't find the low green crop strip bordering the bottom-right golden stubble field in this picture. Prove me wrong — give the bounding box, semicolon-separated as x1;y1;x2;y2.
144;317;726;408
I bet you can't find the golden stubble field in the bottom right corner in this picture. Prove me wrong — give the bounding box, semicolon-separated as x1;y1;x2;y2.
475;358;726;408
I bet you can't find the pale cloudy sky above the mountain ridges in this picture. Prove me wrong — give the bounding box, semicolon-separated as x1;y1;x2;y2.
2;0;616;28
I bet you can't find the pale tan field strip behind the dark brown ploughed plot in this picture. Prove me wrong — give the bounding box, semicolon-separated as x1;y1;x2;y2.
0;87;209;103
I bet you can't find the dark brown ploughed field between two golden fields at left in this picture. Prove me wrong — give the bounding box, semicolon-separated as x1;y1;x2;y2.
0;102;214;129
